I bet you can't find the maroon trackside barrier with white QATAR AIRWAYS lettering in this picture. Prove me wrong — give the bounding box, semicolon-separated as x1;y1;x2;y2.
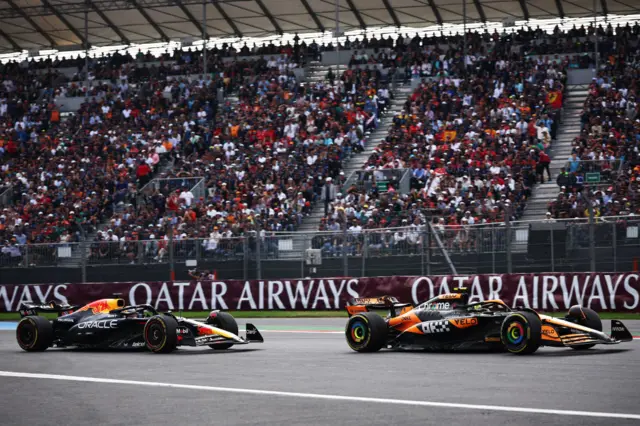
0;273;640;312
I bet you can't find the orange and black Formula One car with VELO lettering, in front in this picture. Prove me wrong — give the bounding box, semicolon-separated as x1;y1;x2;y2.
345;289;633;354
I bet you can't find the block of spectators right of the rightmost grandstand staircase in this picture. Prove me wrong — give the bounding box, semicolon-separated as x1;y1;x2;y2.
548;46;640;219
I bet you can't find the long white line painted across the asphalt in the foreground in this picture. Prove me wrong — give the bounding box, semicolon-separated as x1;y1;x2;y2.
0;371;640;420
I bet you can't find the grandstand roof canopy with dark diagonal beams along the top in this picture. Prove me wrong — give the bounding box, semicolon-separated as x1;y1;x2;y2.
0;0;640;52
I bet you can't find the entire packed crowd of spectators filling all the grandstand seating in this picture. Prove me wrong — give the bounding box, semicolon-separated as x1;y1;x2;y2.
0;22;640;264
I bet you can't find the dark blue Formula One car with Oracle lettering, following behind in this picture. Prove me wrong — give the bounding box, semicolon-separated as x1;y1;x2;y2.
16;299;263;353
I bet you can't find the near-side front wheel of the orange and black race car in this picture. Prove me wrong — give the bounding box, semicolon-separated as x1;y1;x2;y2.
500;311;542;355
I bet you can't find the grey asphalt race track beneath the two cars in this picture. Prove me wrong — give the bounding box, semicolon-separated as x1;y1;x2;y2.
0;319;640;426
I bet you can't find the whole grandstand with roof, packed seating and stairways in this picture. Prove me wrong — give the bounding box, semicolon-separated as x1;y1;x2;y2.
0;0;640;280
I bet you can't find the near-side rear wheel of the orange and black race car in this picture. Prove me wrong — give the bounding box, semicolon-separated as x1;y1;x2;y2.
344;312;388;352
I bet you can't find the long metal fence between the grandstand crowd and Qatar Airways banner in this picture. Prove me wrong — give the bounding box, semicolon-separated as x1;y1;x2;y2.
0;216;640;280
